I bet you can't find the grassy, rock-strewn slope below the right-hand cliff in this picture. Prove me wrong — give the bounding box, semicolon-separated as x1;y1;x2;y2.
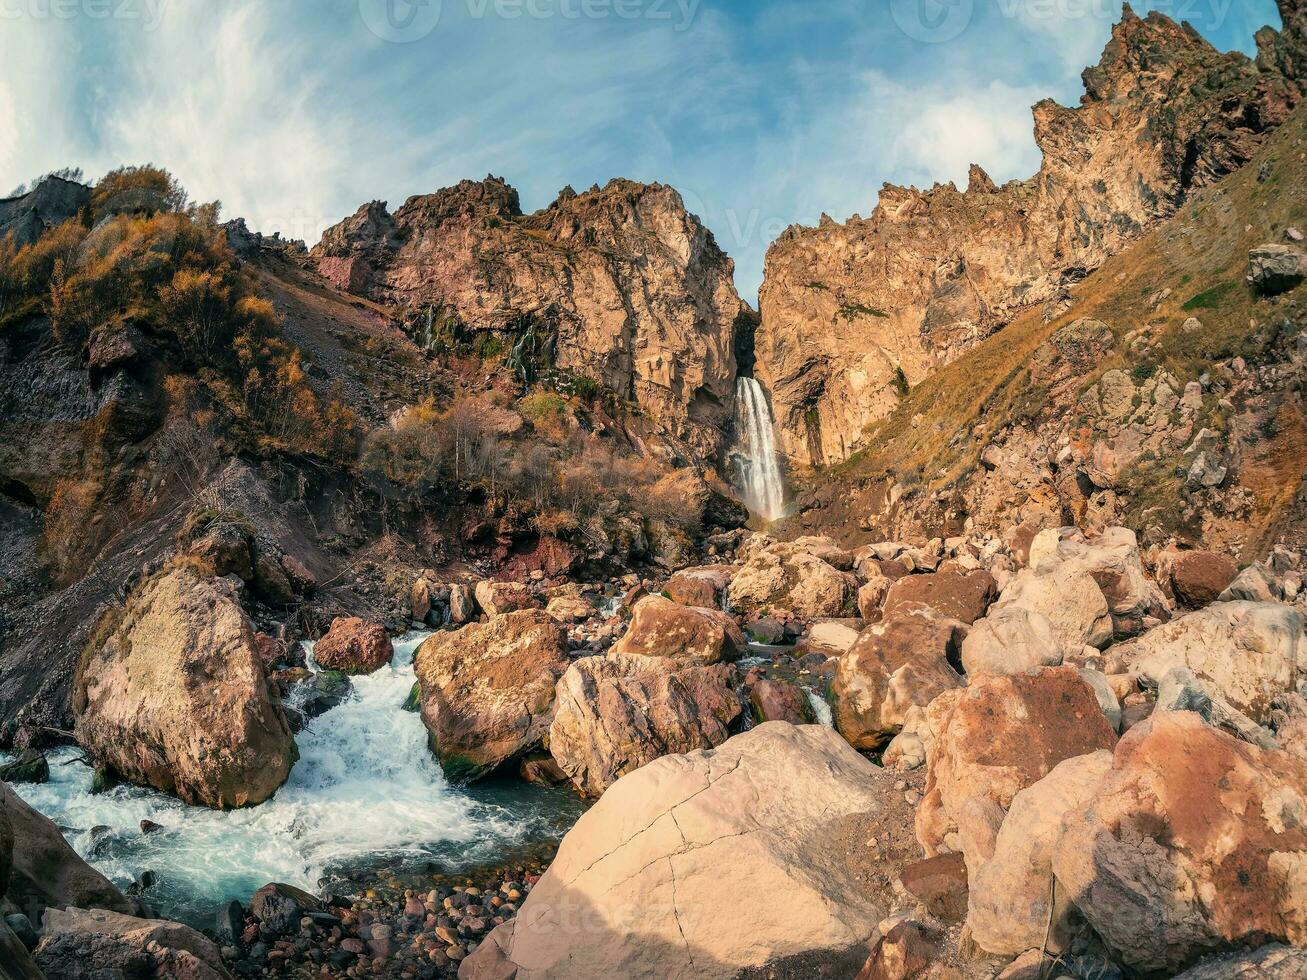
773;98;1307;558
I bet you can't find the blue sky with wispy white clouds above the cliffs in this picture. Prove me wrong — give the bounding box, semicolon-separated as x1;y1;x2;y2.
0;0;1280;302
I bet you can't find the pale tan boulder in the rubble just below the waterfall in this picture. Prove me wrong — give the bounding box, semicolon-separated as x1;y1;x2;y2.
727;542;857;619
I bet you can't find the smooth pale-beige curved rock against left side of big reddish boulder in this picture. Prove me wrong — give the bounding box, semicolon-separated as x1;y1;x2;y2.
967;750;1112;955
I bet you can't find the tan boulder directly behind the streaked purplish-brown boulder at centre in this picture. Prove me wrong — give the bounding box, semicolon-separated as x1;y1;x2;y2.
612;596;749;666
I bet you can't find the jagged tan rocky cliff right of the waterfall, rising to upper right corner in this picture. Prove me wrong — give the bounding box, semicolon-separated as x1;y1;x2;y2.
757;0;1307;465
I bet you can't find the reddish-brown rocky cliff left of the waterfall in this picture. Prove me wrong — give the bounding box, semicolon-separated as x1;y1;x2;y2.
312;176;748;459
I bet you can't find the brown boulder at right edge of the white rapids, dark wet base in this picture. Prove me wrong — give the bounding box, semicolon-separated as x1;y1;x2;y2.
413;609;569;780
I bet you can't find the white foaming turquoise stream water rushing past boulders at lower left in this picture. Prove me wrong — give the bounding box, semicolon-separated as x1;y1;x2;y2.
3;634;580;921
